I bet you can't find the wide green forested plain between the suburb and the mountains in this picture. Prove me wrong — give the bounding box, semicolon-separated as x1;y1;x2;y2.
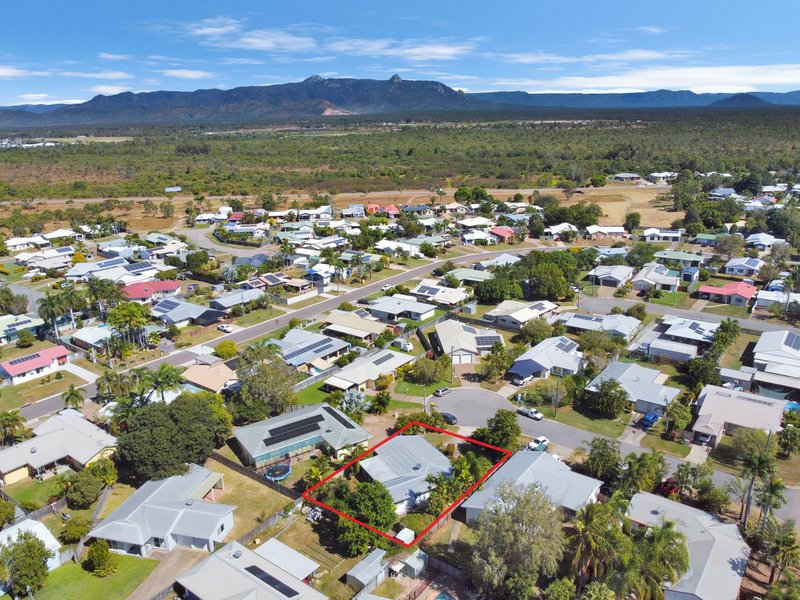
0;108;800;200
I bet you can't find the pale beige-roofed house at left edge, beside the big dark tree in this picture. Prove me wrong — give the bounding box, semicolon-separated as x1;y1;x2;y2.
0;411;117;485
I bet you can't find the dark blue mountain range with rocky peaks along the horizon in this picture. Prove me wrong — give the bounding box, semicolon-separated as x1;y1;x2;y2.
0;75;800;128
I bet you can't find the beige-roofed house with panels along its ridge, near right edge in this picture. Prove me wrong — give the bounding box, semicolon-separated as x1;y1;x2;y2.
692;385;786;448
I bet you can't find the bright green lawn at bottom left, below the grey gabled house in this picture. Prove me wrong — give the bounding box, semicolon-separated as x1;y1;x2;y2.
36;554;158;600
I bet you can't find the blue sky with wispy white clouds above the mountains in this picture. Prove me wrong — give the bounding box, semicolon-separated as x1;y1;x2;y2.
0;0;800;105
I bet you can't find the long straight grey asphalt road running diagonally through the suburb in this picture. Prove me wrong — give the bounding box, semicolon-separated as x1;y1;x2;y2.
20;250;520;421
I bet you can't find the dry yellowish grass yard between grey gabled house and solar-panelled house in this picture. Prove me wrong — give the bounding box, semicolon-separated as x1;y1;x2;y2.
205;459;291;542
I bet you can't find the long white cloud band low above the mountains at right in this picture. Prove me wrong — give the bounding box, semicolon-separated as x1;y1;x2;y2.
493;64;800;93
